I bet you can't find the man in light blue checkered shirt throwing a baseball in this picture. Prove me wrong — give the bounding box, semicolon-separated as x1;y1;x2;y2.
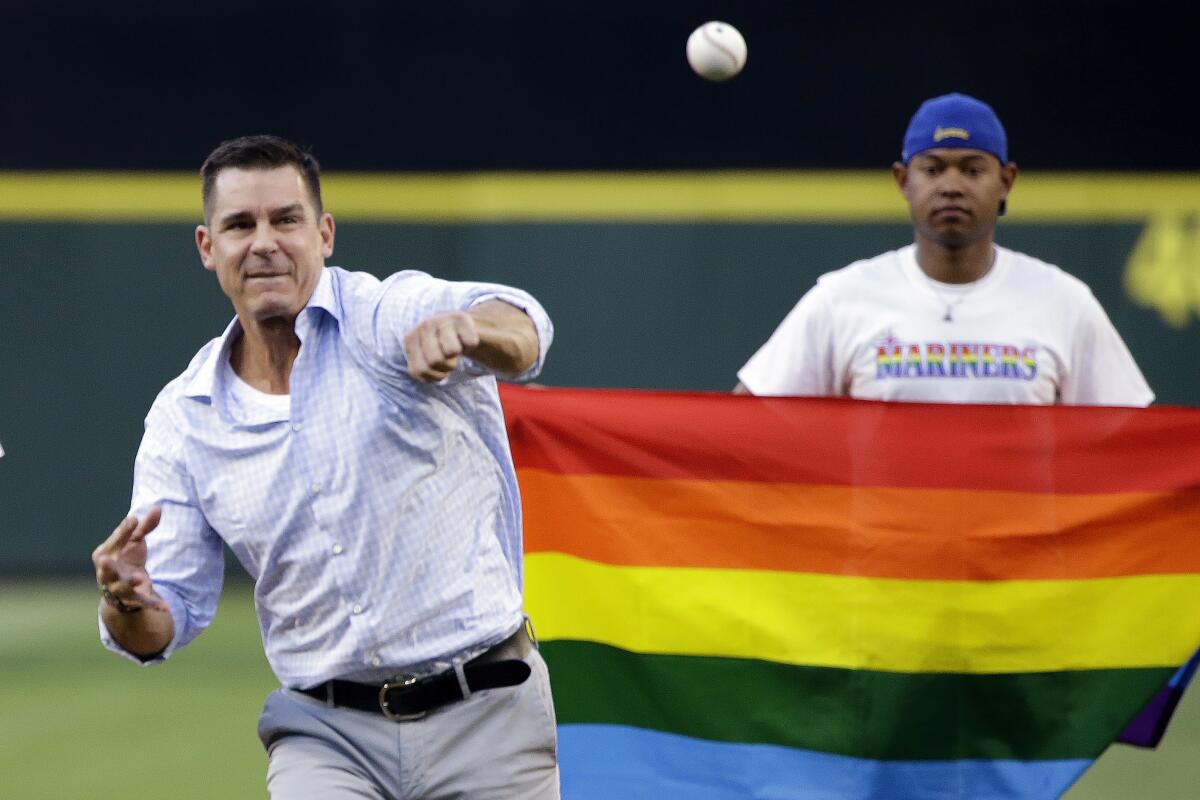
92;137;558;800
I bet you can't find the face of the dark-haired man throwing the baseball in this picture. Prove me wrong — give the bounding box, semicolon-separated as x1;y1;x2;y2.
196;166;334;321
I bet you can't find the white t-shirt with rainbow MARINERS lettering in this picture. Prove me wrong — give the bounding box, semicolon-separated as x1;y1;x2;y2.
738;245;1154;407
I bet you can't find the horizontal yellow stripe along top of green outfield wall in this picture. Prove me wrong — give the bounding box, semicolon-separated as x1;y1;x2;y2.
0;169;1200;223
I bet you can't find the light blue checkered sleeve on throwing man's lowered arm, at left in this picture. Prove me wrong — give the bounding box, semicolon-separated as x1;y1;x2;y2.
100;404;224;664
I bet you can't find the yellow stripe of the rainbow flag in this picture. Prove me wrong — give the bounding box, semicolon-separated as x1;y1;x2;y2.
526;553;1200;673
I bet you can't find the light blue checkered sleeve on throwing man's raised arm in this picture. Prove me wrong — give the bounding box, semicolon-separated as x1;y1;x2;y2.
373;270;554;384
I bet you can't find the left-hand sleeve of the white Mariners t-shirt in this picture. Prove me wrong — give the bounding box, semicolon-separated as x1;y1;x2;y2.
738;283;841;397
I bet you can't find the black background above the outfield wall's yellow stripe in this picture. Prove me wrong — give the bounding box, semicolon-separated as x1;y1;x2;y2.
0;0;1200;170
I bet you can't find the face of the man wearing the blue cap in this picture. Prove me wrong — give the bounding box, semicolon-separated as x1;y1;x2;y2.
892;148;1016;248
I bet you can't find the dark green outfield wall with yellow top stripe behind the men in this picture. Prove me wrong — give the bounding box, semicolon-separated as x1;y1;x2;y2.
0;173;1200;573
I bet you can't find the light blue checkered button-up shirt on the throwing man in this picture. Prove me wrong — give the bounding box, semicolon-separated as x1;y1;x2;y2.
100;267;553;688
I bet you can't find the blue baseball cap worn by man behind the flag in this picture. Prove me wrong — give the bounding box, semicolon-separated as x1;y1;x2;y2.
900;92;1008;166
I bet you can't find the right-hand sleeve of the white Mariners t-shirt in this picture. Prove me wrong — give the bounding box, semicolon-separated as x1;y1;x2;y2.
1060;288;1154;408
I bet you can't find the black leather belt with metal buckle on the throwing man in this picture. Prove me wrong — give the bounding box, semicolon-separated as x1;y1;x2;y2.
298;625;533;722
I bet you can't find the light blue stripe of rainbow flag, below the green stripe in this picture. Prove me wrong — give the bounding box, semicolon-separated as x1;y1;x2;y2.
558;724;1091;800
